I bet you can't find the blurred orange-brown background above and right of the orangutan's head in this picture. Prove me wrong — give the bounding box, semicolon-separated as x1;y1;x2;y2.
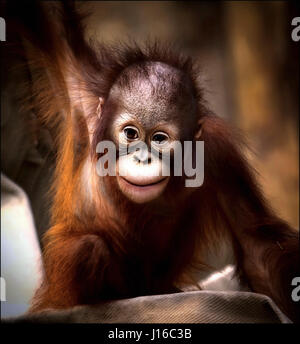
79;1;300;227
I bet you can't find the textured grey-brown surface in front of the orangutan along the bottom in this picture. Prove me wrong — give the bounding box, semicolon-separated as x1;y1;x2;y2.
5;291;290;323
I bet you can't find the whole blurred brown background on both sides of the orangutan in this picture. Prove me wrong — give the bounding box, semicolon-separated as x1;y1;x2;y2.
1;1;300;245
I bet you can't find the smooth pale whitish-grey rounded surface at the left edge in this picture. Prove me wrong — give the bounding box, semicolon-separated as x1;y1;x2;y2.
1;173;42;318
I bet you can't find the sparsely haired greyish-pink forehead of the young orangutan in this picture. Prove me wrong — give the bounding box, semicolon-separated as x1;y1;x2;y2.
111;62;196;121
